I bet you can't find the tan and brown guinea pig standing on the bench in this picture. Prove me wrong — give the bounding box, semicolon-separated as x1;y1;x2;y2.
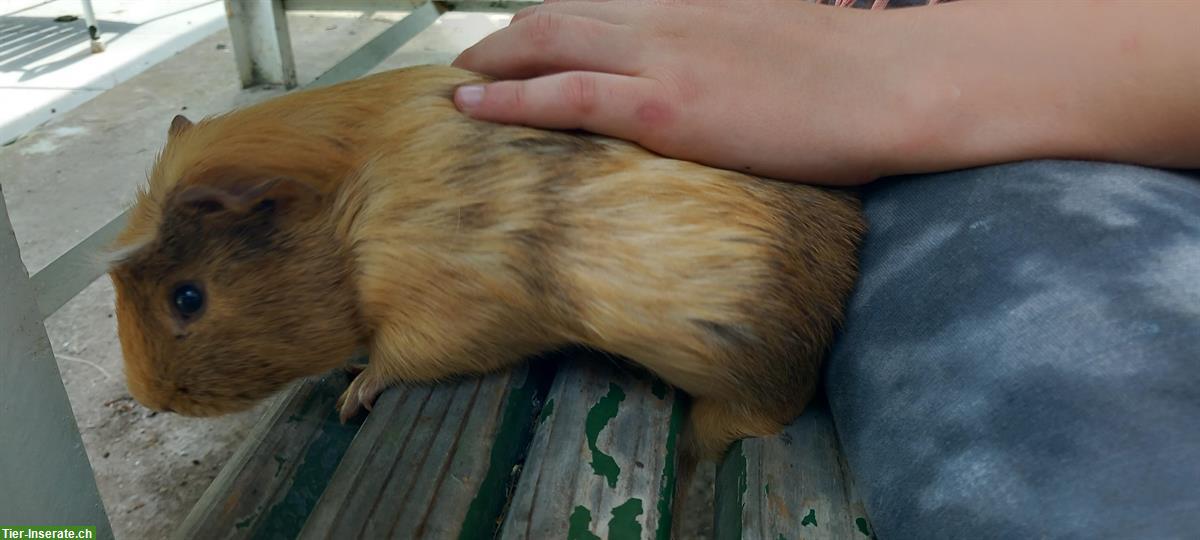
109;66;865;457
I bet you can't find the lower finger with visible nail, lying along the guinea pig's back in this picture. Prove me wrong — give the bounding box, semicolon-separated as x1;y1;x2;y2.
455;72;676;147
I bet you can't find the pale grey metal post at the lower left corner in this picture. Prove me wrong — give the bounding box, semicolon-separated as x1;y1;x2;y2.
0;187;113;539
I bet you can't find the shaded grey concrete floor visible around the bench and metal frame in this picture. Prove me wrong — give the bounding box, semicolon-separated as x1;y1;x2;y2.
0;2;712;539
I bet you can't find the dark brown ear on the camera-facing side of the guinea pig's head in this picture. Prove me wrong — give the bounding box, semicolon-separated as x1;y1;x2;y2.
174;178;319;215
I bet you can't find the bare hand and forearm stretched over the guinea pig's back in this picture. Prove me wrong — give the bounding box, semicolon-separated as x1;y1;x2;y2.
455;0;1200;185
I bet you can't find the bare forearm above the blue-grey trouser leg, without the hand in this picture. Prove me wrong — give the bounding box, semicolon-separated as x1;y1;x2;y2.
892;1;1200;174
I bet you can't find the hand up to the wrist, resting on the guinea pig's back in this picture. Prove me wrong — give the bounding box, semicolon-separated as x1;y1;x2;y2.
454;0;936;185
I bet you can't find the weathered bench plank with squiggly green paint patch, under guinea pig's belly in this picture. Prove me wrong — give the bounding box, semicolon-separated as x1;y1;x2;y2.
500;352;684;539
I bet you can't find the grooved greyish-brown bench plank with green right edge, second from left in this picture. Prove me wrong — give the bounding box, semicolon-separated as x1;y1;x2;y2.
300;367;550;539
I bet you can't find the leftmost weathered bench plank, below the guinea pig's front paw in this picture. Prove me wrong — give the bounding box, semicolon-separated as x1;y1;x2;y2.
175;371;359;539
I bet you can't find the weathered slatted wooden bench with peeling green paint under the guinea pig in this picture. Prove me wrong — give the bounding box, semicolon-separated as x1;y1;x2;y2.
176;349;871;539
